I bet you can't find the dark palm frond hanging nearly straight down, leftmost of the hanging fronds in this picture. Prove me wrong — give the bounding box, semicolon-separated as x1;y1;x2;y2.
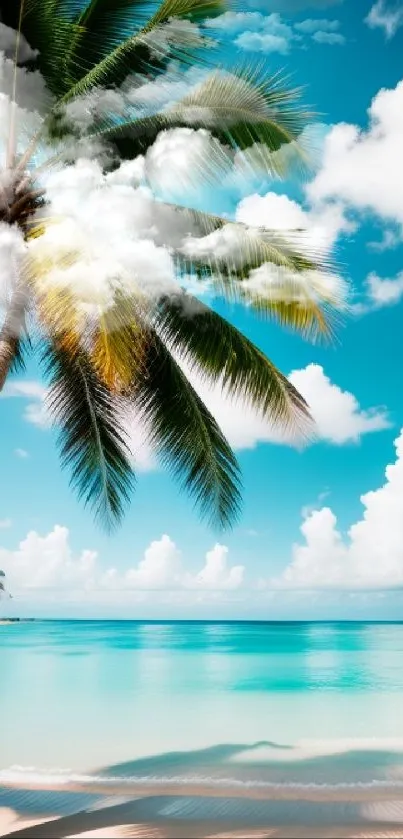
43;341;134;530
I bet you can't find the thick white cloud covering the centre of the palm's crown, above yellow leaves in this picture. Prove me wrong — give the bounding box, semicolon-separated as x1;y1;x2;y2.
30;159;178;310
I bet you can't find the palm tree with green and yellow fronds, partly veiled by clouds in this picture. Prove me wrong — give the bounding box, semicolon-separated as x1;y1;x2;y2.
0;0;341;526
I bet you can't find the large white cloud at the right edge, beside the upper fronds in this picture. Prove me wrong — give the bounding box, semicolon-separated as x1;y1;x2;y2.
307;81;403;235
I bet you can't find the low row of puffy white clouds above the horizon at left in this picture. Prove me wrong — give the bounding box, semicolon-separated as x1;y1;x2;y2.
0;522;244;599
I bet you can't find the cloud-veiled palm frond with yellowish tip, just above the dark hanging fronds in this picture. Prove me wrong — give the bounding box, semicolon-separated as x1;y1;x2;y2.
162;205;340;338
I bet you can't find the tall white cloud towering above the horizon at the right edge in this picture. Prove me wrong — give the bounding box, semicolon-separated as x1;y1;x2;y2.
278;431;403;590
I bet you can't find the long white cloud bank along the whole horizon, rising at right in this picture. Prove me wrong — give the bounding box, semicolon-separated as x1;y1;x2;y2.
0;429;403;606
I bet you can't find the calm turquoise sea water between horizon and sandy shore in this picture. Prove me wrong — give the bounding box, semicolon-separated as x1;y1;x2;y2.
0;621;403;785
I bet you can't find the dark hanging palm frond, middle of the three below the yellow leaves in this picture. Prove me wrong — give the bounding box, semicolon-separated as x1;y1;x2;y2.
133;326;240;527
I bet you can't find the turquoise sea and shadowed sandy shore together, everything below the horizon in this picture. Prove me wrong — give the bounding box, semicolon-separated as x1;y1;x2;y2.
0;621;403;837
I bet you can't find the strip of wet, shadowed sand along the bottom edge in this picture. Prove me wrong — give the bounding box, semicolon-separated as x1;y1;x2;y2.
0;785;403;839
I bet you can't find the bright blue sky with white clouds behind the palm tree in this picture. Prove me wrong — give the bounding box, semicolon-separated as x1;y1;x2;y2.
0;0;403;619
